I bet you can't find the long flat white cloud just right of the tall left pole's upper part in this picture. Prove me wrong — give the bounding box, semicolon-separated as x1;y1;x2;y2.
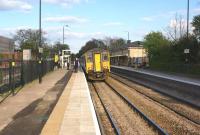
43;16;88;23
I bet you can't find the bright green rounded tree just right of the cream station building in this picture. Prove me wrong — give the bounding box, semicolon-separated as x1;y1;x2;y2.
144;32;170;58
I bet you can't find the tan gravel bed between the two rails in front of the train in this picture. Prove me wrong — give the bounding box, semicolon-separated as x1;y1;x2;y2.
95;82;157;135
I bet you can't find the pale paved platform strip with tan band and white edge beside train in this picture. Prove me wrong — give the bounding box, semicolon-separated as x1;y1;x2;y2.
41;71;100;135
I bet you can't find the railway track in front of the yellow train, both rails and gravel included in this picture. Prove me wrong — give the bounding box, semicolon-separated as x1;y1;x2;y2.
88;82;167;134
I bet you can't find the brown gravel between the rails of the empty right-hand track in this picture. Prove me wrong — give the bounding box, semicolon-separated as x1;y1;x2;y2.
112;75;200;125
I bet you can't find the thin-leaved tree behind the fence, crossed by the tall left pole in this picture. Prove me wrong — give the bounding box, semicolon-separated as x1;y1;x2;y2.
14;29;46;53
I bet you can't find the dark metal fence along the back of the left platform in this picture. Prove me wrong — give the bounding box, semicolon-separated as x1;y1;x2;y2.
0;59;54;94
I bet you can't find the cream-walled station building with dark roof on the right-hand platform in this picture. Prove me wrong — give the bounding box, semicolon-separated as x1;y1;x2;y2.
110;41;149;67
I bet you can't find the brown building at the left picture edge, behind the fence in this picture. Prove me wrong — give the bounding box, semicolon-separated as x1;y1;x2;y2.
0;36;14;53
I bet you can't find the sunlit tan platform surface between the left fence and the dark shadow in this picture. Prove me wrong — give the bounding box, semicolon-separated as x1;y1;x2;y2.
0;69;67;131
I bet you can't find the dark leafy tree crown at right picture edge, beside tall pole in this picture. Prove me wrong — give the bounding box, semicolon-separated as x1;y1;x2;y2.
192;15;200;40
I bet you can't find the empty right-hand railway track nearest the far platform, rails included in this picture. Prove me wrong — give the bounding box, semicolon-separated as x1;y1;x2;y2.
111;74;200;125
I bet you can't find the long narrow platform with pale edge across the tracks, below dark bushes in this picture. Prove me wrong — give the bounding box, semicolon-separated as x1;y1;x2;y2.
111;66;200;86
